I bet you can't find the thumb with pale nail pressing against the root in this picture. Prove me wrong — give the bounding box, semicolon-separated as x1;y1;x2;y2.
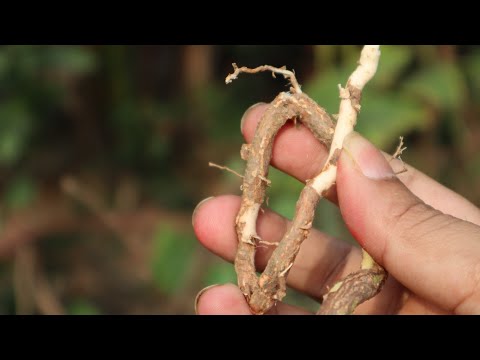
337;132;480;313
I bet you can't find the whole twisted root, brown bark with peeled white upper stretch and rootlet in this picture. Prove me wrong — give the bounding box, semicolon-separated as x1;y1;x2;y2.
222;45;386;314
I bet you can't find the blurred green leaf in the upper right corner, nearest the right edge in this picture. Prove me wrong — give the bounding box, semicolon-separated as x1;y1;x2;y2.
402;63;467;110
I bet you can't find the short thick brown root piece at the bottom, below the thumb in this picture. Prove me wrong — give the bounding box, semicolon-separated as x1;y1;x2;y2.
317;265;387;315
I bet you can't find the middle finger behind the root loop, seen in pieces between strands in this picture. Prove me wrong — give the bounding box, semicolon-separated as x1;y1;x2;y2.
194;195;361;299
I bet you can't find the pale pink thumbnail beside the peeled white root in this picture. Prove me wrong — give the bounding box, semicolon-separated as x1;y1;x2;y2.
343;131;395;180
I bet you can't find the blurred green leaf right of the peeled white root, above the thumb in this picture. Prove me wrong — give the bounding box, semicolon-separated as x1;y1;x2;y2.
356;89;432;148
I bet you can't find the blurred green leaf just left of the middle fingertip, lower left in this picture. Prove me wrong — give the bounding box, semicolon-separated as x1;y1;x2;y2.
151;225;197;294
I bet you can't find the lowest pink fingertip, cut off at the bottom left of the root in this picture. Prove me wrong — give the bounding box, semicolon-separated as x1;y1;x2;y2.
197;284;252;315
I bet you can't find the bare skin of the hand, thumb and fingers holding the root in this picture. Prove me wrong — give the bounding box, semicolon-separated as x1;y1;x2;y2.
192;104;480;315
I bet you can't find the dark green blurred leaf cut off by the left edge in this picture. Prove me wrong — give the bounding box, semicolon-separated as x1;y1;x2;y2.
0;99;33;165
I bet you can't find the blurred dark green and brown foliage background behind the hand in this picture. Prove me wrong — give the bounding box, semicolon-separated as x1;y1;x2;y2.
0;45;480;314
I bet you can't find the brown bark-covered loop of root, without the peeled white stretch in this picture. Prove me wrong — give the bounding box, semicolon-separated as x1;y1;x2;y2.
235;93;334;313
